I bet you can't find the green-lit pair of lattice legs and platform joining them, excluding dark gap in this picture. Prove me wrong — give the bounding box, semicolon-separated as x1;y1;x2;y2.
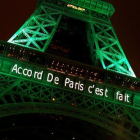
8;0;136;77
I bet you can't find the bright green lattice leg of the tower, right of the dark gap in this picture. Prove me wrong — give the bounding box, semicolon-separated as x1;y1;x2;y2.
87;19;135;77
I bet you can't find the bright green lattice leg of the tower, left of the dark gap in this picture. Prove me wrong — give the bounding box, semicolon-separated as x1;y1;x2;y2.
8;2;62;51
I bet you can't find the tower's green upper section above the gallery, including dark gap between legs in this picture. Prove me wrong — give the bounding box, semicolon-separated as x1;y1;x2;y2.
8;0;135;77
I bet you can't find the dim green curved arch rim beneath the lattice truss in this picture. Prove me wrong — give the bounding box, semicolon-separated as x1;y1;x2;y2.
0;99;138;140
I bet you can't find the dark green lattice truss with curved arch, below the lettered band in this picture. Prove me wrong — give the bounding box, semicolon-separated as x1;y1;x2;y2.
0;74;140;140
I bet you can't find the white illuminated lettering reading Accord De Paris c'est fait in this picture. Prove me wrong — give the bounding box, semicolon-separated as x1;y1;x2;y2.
11;64;132;104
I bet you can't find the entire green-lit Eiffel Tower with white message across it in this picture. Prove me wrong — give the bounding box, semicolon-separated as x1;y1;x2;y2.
0;0;140;140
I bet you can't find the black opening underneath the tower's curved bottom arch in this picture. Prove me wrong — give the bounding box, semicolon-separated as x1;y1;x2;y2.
0;113;112;140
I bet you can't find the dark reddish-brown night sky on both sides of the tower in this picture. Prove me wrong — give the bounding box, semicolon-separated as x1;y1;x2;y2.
0;0;140;78
